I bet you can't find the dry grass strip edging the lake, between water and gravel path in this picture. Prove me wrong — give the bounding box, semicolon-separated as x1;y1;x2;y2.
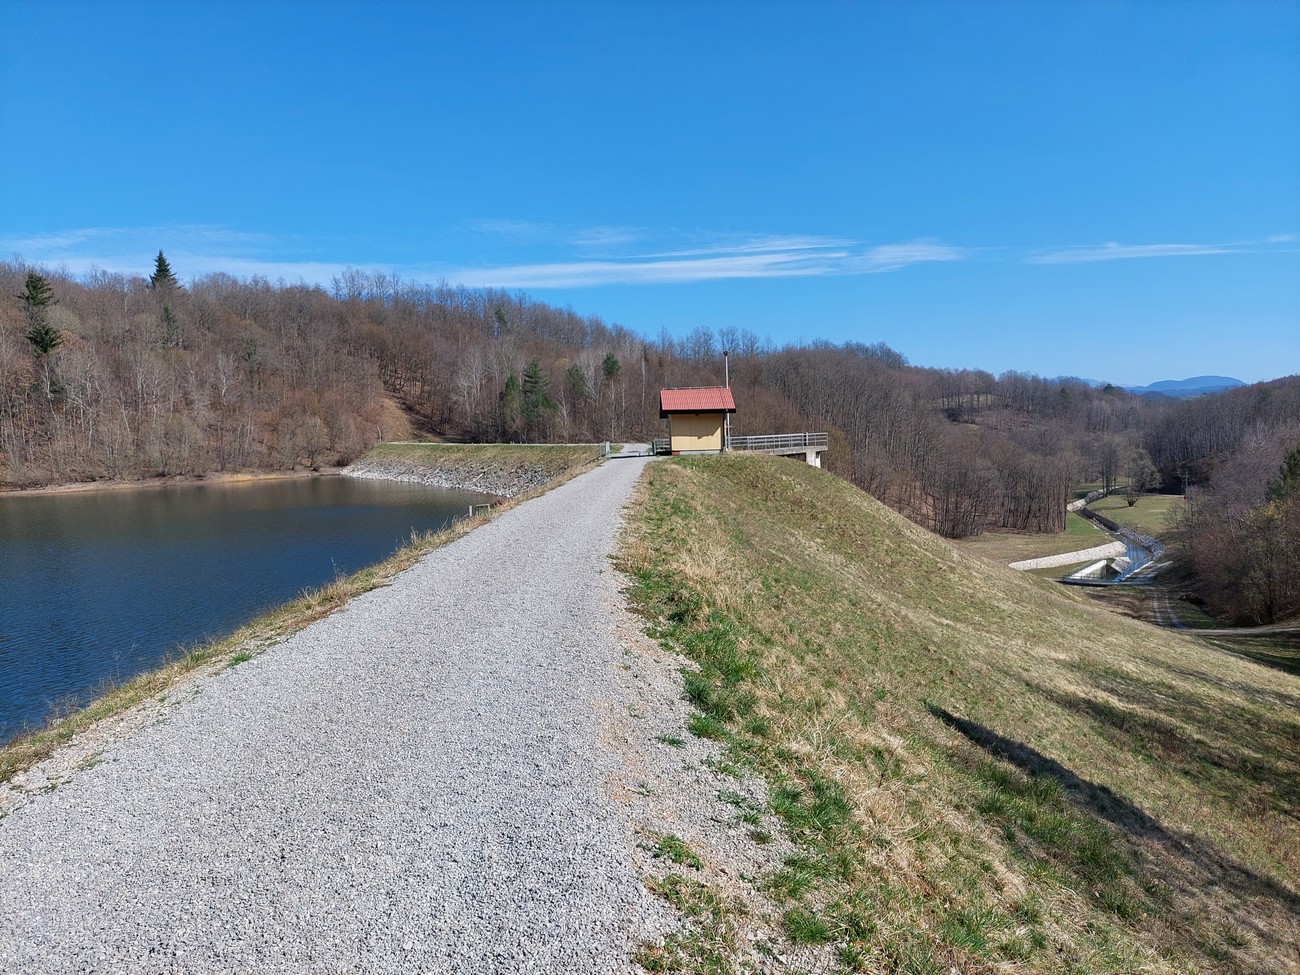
0;445;597;783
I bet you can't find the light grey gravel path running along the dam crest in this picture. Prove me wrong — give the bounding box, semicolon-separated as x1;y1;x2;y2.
0;459;680;972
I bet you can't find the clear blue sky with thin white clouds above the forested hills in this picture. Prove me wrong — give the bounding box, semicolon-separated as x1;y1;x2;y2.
0;0;1300;384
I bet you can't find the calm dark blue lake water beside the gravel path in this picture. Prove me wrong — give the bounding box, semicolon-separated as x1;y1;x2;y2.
0;477;489;742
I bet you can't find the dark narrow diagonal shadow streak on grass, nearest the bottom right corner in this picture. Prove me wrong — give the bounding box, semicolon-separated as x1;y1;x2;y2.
927;705;1300;971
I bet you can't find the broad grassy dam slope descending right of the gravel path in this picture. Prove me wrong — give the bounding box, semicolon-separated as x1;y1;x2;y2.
621;455;1300;972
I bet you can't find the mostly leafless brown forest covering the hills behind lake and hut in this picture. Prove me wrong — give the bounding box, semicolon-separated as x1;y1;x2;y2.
0;252;1300;623
